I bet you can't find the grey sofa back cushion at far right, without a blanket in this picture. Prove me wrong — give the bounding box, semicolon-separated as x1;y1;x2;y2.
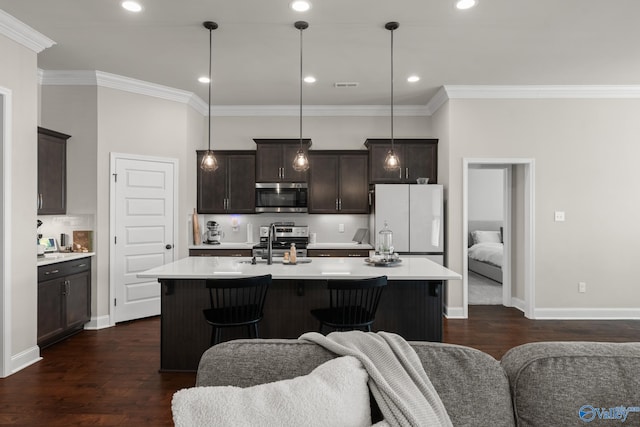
501;342;640;427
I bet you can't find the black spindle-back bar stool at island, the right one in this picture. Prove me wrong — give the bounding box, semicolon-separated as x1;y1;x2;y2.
311;276;387;333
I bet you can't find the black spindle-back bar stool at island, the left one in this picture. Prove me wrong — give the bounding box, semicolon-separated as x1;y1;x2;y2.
203;274;271;346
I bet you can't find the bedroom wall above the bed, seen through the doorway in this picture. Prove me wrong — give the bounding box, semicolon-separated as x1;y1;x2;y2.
468;168;504;221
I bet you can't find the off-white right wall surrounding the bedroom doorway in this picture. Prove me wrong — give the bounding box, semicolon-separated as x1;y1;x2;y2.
447;99;640;315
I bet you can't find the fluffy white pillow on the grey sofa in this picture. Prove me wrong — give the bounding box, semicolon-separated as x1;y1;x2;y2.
171;356;371;427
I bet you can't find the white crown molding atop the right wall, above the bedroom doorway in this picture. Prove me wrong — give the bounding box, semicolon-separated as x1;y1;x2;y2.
443;85;640;99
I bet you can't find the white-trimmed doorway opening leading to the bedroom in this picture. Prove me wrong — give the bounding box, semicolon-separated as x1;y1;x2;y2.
462;158;535;318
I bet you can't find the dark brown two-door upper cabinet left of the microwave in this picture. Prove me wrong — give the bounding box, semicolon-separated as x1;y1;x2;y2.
196;150;256;214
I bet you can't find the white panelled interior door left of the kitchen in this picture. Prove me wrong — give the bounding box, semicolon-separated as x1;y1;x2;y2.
112;156;176;322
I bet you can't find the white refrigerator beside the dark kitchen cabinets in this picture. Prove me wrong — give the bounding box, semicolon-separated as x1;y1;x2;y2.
369;184;444;265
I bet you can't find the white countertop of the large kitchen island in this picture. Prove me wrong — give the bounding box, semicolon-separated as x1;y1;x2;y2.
137;257;462;280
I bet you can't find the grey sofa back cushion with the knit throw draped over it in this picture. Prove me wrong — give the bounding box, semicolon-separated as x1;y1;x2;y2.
196;339;515;427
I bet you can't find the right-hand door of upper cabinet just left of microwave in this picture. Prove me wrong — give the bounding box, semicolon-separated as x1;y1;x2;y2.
227;153;256;214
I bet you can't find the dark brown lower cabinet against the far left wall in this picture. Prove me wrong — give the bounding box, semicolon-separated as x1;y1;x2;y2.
38;257;91;348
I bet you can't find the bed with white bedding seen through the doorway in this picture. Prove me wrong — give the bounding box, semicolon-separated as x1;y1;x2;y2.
467;221;504;283
